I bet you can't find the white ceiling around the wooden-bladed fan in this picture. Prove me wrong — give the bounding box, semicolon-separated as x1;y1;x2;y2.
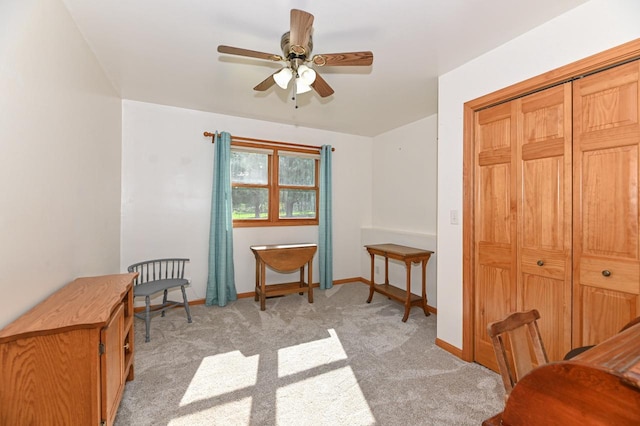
63;0;586;136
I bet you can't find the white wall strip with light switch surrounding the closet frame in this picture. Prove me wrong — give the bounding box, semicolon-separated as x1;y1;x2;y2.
437;0;640;348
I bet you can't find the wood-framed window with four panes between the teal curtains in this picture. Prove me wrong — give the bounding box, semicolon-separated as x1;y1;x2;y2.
231;142;320;226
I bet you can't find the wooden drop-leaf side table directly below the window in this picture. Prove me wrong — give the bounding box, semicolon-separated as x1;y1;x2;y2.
250;244;318;311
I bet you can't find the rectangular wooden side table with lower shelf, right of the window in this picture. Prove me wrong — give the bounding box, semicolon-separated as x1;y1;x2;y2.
365;244;433;322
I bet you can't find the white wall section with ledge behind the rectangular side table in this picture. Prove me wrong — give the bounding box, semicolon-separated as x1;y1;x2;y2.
361;115;438;307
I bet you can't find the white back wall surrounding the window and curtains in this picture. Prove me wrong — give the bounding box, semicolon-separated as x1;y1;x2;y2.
121;100;372;300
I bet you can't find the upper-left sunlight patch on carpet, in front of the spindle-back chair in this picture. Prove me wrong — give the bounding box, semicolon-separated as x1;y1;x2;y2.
180;351;260;407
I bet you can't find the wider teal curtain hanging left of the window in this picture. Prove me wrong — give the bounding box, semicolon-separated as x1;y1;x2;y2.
205;132;238;306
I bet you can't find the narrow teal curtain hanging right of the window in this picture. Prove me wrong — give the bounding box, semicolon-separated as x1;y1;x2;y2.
318;145;333;289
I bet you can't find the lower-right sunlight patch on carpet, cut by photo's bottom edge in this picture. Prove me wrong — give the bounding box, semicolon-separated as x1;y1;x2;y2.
276;367;375;426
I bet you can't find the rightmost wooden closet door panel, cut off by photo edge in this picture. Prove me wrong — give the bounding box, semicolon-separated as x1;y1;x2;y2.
573;61;640;346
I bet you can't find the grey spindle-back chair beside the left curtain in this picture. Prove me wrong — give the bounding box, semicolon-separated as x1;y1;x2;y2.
127;258;191;342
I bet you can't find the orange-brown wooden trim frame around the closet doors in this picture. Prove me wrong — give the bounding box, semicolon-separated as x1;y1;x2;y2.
461;39;640;361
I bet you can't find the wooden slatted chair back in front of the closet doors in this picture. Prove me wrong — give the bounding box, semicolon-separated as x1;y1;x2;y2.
487;309;549;401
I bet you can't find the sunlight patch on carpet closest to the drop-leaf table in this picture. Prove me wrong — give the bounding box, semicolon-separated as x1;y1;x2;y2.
278;328;347;377
